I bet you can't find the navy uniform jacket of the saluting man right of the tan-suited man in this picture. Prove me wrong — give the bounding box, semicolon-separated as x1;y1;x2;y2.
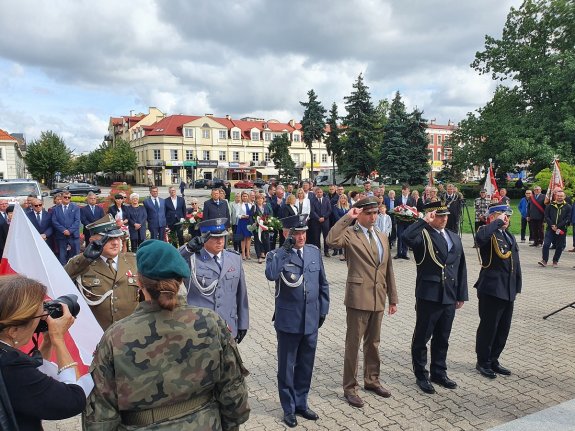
403;220;469;304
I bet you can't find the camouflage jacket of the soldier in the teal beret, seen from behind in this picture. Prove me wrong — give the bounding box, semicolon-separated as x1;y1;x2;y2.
83;297;250;431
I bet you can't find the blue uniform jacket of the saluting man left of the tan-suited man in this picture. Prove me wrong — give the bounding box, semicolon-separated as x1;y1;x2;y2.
266;245;329;335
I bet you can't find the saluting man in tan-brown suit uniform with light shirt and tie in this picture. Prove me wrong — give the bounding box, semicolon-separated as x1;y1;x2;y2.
327;198;398;407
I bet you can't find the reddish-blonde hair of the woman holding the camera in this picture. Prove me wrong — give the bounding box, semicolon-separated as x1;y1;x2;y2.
0;275;46;330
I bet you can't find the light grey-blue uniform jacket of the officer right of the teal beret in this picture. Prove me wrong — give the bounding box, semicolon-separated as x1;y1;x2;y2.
179;246;249;338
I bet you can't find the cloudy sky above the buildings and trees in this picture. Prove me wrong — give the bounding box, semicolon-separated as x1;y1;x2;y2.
0;0;521;153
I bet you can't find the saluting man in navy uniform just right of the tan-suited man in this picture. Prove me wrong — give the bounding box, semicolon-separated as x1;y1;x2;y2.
403;201;469;394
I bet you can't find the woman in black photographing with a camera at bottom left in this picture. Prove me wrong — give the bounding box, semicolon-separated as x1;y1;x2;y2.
0;275;93;431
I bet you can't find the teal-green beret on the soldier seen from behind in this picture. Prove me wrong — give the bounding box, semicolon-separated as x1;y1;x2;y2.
136;239;190;280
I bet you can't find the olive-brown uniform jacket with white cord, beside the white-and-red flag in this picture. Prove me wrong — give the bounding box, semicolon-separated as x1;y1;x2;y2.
64;253;138;330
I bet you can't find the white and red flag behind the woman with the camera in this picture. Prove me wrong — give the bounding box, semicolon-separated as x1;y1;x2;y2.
0;204;103;374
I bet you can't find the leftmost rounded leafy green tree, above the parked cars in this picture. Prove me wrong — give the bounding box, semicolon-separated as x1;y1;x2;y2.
24;130;72;188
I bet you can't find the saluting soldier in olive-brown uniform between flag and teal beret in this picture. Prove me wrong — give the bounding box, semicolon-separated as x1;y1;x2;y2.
64;214;138;330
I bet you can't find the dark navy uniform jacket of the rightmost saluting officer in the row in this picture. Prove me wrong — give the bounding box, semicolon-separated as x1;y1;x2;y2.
475;220;522;301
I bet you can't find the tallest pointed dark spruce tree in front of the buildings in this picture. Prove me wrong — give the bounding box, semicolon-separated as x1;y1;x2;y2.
339;74;378;177
